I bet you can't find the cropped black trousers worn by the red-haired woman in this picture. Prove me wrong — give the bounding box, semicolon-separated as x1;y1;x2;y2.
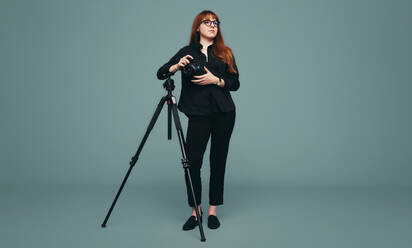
185;110;236;207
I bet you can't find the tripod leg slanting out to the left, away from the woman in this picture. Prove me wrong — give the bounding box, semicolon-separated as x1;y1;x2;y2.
102;96;168;227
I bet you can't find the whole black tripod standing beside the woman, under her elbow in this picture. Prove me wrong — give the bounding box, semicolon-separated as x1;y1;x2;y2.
102;73;206;241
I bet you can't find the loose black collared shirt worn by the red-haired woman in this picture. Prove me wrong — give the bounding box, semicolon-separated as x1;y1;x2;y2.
157;42;240;116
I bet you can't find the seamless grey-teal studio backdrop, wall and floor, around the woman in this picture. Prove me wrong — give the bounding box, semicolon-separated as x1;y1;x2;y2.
0;0;412;247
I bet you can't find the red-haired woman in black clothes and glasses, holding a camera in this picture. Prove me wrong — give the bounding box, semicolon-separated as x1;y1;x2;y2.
157;10;239;230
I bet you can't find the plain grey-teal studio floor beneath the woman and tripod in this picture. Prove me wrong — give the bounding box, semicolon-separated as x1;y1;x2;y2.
0;183;412;248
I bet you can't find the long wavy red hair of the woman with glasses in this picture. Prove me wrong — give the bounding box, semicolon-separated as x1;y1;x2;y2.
189;10;238;73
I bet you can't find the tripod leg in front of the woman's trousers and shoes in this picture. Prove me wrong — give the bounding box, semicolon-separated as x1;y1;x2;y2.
172;96;206;242
